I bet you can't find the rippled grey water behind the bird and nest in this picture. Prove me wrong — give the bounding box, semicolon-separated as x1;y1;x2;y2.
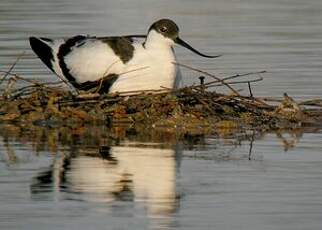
0;0;322;99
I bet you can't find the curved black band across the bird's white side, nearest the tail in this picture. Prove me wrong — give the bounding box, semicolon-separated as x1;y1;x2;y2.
57;35;86;88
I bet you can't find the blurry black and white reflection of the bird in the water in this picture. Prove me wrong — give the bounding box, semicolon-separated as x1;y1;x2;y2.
31;143;176;215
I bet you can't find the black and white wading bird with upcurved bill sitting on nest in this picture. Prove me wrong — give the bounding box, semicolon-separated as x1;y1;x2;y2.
29;19;220;93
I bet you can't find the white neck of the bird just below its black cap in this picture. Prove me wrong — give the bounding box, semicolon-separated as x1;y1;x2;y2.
144;30;174;49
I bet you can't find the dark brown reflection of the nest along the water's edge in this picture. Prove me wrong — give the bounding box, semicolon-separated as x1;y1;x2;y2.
0;124;320;165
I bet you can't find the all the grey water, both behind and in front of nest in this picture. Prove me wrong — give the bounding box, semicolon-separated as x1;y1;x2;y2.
0;0;322;230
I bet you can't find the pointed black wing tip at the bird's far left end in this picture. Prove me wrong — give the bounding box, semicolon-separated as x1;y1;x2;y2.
29;37;54;71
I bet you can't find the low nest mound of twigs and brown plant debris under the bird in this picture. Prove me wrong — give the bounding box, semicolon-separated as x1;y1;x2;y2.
0;63;322;129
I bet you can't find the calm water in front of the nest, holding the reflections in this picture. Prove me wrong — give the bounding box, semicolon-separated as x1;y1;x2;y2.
0;125;322;229
